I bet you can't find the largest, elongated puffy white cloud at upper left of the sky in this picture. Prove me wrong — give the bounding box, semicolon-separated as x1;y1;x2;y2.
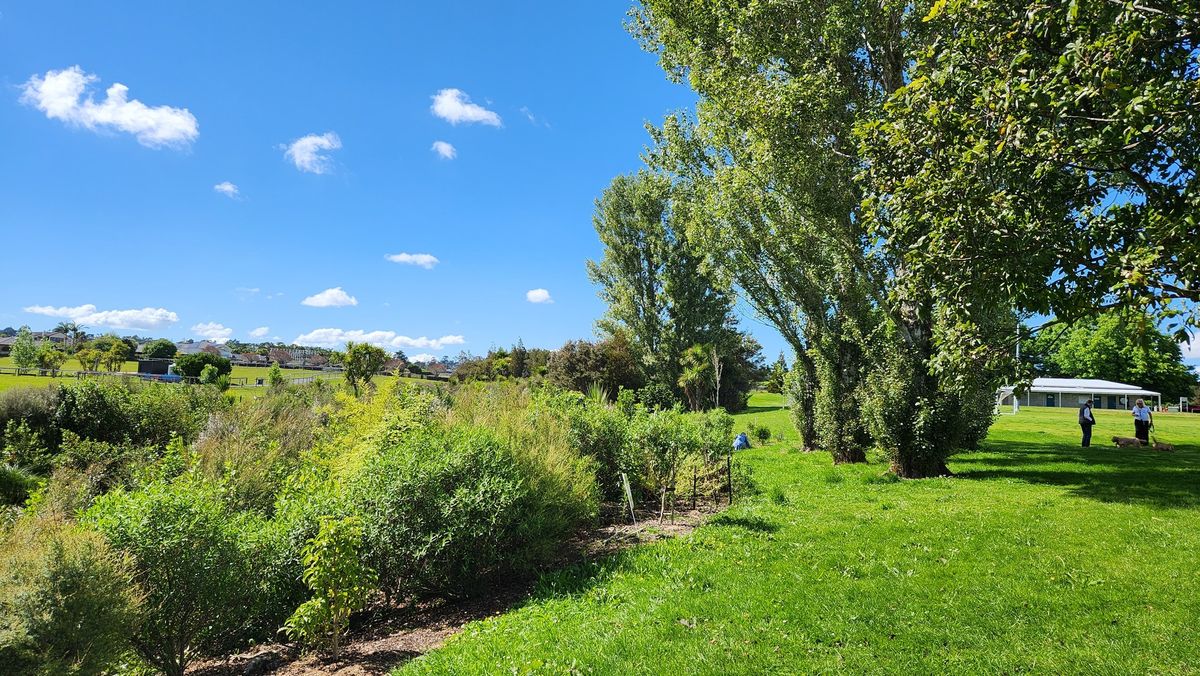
20;66;200;148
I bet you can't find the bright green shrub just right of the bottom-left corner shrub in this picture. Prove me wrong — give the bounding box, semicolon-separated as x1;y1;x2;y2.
84;480;256;676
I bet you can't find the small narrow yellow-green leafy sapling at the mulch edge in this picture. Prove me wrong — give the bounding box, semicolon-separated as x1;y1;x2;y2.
284;518;374;654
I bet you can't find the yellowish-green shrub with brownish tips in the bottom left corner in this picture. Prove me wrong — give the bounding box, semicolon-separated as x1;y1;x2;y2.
0;519;140;675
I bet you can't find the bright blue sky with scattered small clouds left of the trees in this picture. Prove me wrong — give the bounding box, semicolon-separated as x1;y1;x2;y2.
0;0;782;357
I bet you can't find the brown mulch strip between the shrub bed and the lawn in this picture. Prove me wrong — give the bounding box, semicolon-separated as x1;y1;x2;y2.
187;507;714;676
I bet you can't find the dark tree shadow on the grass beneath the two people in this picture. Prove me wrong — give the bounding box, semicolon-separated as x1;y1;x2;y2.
952;442;1200;508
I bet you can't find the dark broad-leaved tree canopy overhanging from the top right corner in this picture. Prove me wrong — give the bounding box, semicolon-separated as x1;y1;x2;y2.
863;0;1200;340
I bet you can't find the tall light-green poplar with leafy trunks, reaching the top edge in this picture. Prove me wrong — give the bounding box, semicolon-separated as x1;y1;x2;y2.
632;0;1015;478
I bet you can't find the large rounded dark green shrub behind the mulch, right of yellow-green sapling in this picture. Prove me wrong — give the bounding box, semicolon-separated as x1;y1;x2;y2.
347;429;529;594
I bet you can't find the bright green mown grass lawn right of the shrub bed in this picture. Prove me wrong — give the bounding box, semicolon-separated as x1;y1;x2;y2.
397;395;1200;674
